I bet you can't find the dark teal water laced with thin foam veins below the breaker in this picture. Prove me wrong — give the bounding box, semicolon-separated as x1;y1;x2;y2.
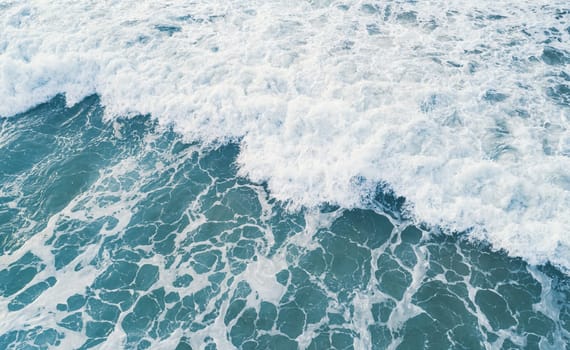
0;96;570;350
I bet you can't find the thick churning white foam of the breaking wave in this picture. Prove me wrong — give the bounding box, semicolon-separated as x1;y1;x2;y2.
0;0;570;268
